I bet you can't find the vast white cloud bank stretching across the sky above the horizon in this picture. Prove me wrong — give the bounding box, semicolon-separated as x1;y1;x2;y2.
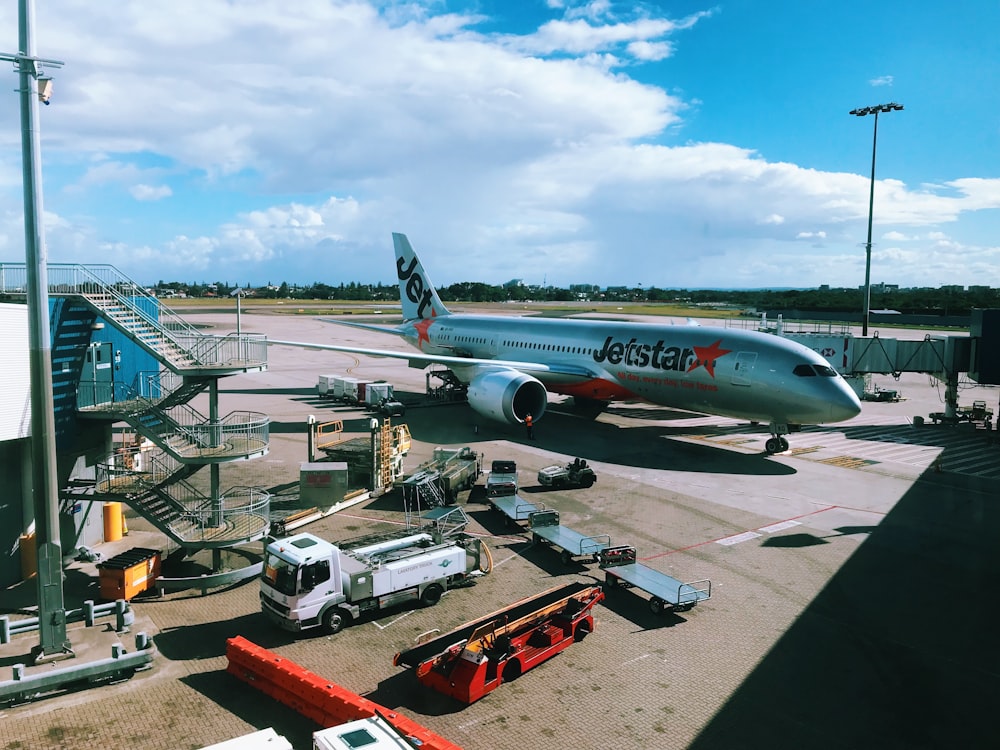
0;0;1000;286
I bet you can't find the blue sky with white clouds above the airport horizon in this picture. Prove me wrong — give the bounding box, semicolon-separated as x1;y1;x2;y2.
0;0;1000;289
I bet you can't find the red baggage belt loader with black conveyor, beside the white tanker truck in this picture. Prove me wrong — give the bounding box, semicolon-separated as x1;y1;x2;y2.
392;582;604;703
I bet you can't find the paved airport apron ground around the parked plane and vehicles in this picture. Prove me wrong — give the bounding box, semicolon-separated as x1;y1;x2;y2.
0;312;1000;750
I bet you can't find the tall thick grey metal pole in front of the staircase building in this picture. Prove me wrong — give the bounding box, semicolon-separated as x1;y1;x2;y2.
0;0;73;663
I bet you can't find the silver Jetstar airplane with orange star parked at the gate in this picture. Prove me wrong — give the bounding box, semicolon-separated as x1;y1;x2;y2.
270;233;861;453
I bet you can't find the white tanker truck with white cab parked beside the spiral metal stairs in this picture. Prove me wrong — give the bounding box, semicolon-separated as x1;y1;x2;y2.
260;532;482;634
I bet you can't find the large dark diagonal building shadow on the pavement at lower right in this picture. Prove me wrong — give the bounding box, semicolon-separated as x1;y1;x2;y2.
690;474;1000;750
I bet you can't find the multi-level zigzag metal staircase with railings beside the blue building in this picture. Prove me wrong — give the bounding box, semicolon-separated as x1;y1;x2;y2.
0;263;270;549
